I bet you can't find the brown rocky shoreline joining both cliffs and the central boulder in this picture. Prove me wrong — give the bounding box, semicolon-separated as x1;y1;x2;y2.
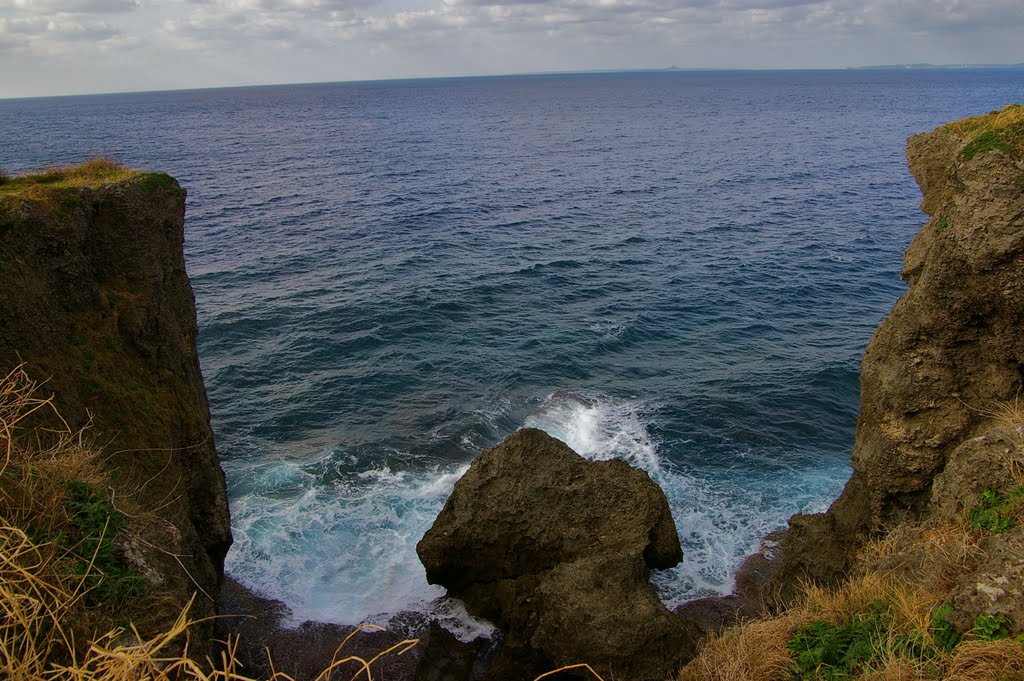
0;105;1024;681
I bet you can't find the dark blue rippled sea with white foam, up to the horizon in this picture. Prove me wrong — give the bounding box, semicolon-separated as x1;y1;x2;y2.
6;70;1024;633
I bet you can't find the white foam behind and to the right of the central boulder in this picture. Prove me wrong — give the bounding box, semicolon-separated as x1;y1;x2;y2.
524;390;847;606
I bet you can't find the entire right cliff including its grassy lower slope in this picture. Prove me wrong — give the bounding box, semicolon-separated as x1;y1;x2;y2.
679;104;1024;681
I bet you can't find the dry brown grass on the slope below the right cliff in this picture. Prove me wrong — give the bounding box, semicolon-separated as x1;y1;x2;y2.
679;524;1024;681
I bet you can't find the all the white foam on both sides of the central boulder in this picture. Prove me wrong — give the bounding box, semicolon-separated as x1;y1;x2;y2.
227;390;846;640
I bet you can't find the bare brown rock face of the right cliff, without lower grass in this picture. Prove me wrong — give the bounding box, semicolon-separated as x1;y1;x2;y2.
776;105;1024;593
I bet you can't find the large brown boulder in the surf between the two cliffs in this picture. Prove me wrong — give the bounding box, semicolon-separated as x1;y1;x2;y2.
417;428;699;680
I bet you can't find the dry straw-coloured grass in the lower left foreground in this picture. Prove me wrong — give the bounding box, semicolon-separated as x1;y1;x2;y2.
0;369;418;681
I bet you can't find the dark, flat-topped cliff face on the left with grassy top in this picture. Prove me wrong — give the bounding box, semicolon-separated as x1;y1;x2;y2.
0;170;231;636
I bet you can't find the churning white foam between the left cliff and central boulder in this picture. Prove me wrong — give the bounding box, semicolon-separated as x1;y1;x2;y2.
226;453;481;637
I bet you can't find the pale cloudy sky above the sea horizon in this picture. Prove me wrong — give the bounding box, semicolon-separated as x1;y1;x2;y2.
0;0;1024;97
